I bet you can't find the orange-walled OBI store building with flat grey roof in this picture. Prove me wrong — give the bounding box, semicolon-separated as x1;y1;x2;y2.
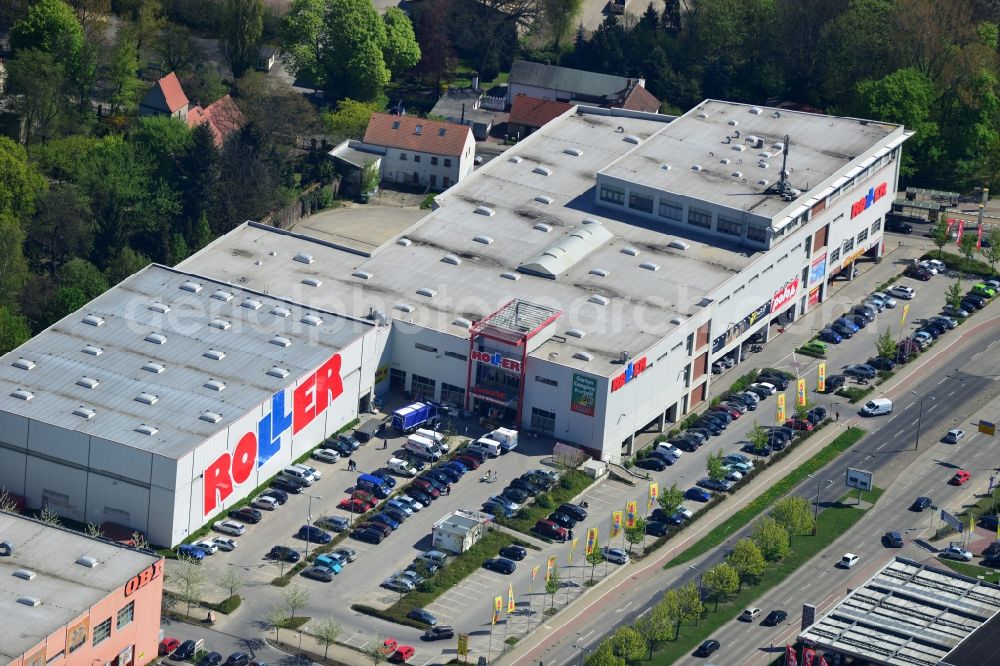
0;513;163;666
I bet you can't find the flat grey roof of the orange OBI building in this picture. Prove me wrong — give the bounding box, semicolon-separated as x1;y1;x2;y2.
0;513;160;663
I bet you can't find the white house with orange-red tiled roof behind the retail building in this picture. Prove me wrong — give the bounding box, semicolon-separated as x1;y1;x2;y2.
363;113;476;190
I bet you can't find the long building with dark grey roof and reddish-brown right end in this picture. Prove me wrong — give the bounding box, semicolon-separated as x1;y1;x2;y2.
507;60;660;113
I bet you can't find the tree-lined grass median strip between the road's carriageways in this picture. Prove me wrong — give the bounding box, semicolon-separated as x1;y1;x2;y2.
648;490;882;666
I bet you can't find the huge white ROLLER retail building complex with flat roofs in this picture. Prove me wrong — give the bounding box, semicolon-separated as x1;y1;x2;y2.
0;101;910;544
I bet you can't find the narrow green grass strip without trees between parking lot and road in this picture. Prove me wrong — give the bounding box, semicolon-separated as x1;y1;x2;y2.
664;428;865;569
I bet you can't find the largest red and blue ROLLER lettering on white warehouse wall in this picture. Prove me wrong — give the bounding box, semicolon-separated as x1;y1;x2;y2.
204;354;344;516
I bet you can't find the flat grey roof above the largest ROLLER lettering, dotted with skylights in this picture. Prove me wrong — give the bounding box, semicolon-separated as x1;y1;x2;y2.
0;262;371;459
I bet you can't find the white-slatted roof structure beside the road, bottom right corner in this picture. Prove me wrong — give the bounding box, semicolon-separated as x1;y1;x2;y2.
798;557;1000;666
